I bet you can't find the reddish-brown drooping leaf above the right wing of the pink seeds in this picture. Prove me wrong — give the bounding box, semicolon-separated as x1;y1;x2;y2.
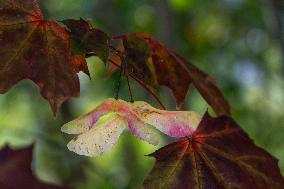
122;33;230;115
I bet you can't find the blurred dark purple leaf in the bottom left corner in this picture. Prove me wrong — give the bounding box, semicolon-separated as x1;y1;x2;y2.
0;146;72;189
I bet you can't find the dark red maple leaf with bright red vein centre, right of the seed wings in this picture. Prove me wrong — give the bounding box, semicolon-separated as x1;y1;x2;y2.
144;113;284;189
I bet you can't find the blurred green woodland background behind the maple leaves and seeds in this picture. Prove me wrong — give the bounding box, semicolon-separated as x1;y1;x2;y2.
0;0;284;189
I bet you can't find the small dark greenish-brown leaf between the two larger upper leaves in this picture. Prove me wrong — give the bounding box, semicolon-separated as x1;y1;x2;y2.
62;18;110;62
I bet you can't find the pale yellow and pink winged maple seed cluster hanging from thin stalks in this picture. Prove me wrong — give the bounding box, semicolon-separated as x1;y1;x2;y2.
61;99;200;156
